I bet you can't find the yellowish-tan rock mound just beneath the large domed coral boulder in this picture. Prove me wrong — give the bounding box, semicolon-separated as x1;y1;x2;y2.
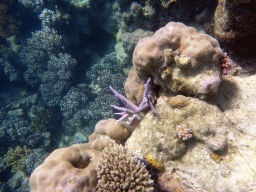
126;96;227;163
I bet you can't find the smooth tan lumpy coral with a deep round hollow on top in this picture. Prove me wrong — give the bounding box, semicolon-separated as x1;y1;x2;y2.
30;140;109;192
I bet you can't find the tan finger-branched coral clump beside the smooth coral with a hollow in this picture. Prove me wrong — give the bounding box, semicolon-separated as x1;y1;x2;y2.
95;144;154;192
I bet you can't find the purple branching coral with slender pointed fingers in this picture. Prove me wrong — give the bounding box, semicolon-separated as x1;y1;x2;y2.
109;78;156;124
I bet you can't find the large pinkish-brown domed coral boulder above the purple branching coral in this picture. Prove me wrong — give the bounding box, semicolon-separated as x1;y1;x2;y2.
131;22;223;98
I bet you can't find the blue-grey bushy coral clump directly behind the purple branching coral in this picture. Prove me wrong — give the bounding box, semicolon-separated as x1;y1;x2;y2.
85;53;125;124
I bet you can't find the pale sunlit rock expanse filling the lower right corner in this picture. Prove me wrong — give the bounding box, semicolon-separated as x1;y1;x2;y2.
126;75;256;191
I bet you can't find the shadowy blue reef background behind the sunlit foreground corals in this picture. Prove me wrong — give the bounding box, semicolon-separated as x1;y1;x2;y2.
0;0;256;192
